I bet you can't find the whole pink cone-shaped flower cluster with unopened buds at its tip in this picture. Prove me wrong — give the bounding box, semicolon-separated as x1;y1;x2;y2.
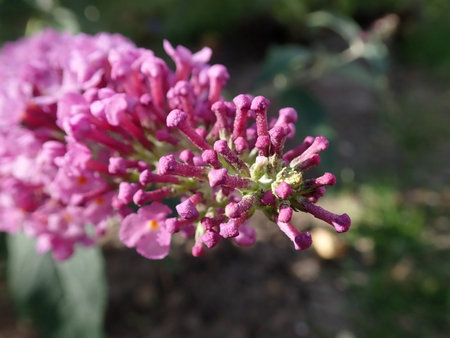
0;30;350;260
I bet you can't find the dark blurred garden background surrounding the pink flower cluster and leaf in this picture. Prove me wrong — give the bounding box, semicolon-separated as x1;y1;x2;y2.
0;0;450;338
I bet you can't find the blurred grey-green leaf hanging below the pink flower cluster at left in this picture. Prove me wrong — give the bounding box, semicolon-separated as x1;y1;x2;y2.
7;234;106;338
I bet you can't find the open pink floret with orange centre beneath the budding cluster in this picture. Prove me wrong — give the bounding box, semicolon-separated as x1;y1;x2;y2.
119;202;172;259
